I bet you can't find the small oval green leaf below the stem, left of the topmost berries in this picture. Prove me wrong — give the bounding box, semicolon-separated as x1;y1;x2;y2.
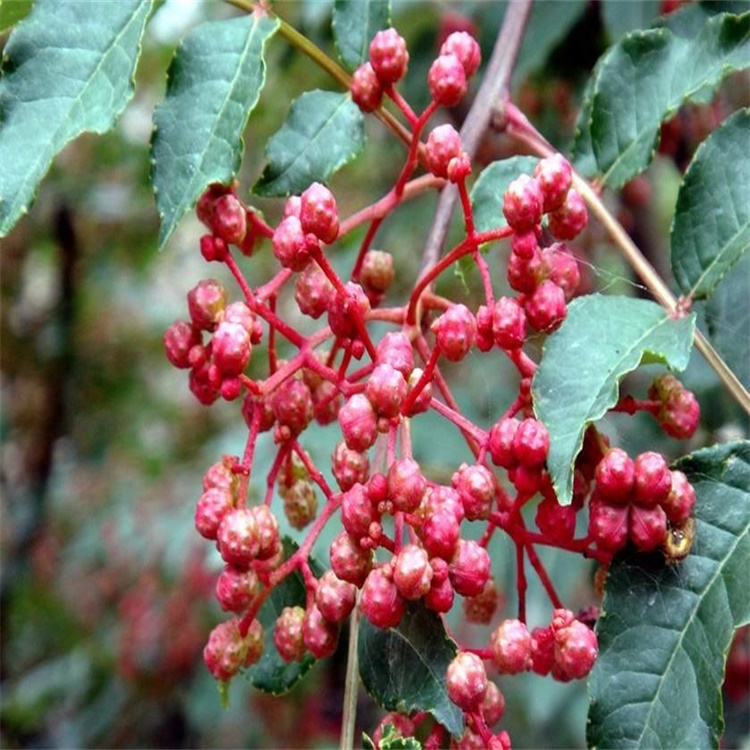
253;90;365;196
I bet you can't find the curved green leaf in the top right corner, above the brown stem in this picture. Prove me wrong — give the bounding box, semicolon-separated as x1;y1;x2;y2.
574;13;750;188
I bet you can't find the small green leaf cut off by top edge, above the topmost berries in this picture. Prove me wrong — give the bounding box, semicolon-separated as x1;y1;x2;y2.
333;0;391;70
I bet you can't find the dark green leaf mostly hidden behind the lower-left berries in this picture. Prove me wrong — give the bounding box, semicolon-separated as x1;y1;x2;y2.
241;537;322;695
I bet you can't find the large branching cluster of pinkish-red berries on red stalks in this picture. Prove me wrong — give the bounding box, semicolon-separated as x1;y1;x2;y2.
164;29;698;748
